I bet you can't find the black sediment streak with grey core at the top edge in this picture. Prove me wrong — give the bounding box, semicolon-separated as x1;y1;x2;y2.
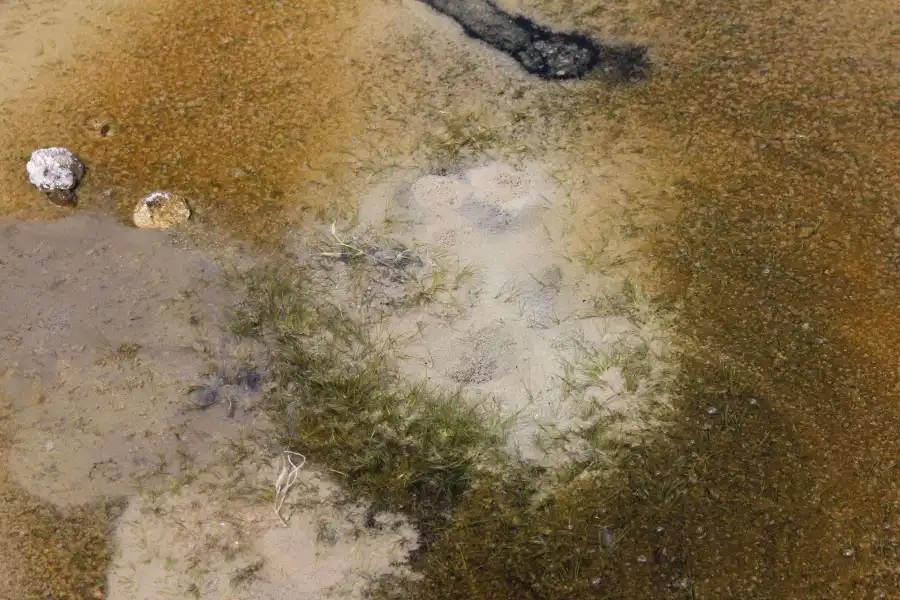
423;0;648;81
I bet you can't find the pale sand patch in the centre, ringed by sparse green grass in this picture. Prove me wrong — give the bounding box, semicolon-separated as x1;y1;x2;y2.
292;162;668;459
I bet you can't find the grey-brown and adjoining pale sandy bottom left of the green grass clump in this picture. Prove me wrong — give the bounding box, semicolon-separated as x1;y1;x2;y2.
0;215;415;600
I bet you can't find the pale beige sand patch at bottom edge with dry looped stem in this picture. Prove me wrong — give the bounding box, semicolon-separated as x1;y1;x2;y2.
109;446;417;600
